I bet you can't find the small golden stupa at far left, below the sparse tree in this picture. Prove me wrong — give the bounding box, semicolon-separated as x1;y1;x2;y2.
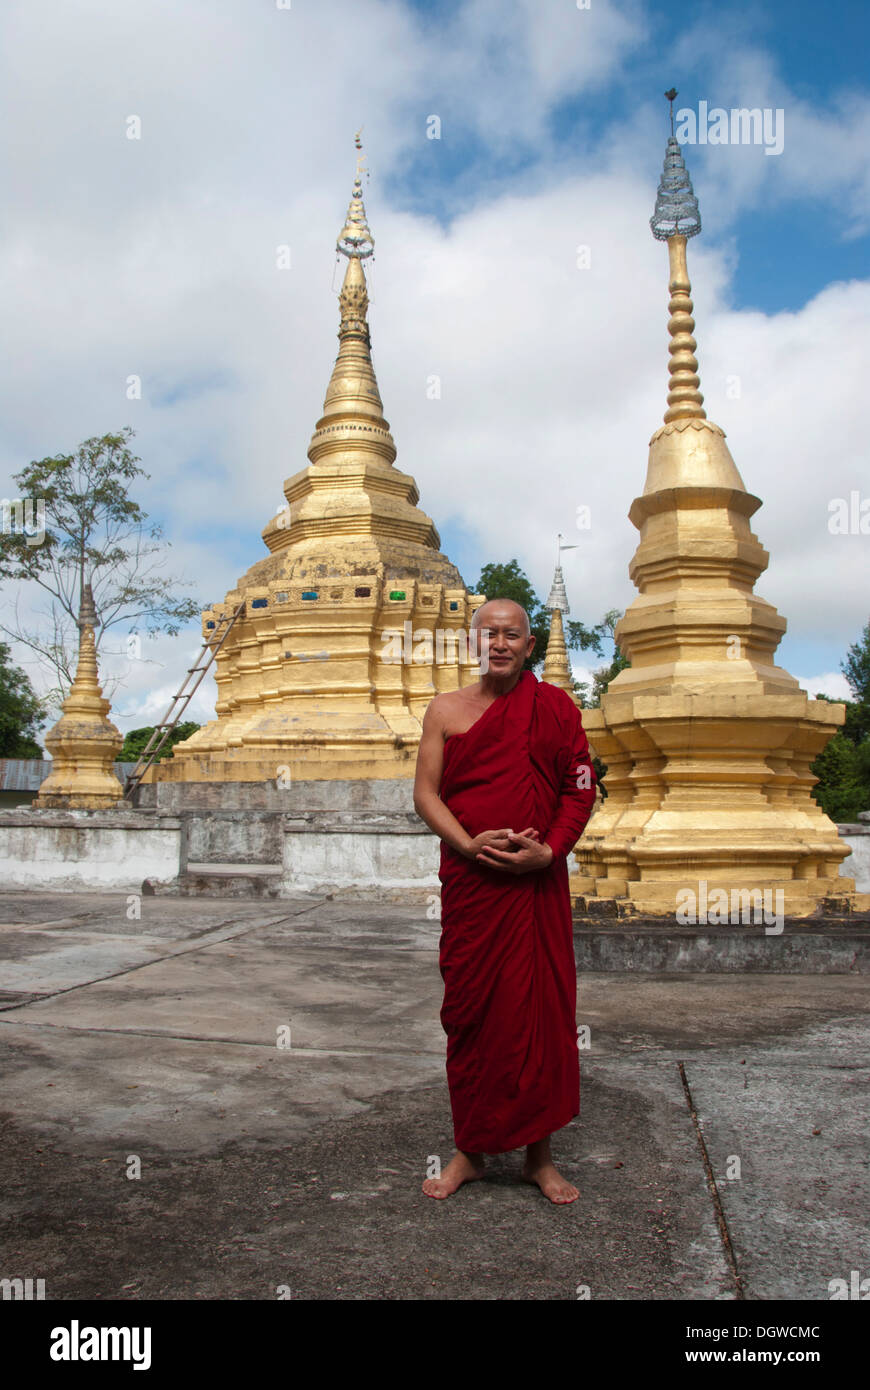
33;584;124;810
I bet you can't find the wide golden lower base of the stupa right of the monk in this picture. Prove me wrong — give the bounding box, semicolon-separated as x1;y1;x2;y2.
571;692;866;922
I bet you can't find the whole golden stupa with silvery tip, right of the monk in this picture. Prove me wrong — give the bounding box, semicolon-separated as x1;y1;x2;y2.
573;102;855;916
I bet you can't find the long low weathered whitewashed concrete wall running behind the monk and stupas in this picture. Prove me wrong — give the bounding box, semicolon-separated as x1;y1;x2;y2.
0;781;870;897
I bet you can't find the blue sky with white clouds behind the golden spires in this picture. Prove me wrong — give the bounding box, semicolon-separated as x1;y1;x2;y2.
0;0;870;731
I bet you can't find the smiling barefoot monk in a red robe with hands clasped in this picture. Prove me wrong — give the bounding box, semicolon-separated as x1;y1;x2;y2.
414;599;595;1204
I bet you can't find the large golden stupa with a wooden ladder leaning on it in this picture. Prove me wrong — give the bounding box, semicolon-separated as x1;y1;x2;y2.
157;149;484;781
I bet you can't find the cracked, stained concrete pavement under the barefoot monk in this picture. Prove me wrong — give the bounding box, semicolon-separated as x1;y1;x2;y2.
0;892;870;1301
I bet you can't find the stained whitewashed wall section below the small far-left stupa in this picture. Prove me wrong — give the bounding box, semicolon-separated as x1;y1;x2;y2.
0;809;181;892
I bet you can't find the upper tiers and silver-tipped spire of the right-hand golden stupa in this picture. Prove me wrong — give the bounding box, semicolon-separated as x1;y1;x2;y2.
609;88;798;694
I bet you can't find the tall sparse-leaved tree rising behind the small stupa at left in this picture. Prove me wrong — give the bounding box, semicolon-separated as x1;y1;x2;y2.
0;425;199;705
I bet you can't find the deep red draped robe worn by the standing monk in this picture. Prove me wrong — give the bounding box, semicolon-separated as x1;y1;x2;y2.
439;671;595;1154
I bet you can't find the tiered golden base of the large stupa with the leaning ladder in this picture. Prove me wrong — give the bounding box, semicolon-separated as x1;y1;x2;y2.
159;572;484;781
